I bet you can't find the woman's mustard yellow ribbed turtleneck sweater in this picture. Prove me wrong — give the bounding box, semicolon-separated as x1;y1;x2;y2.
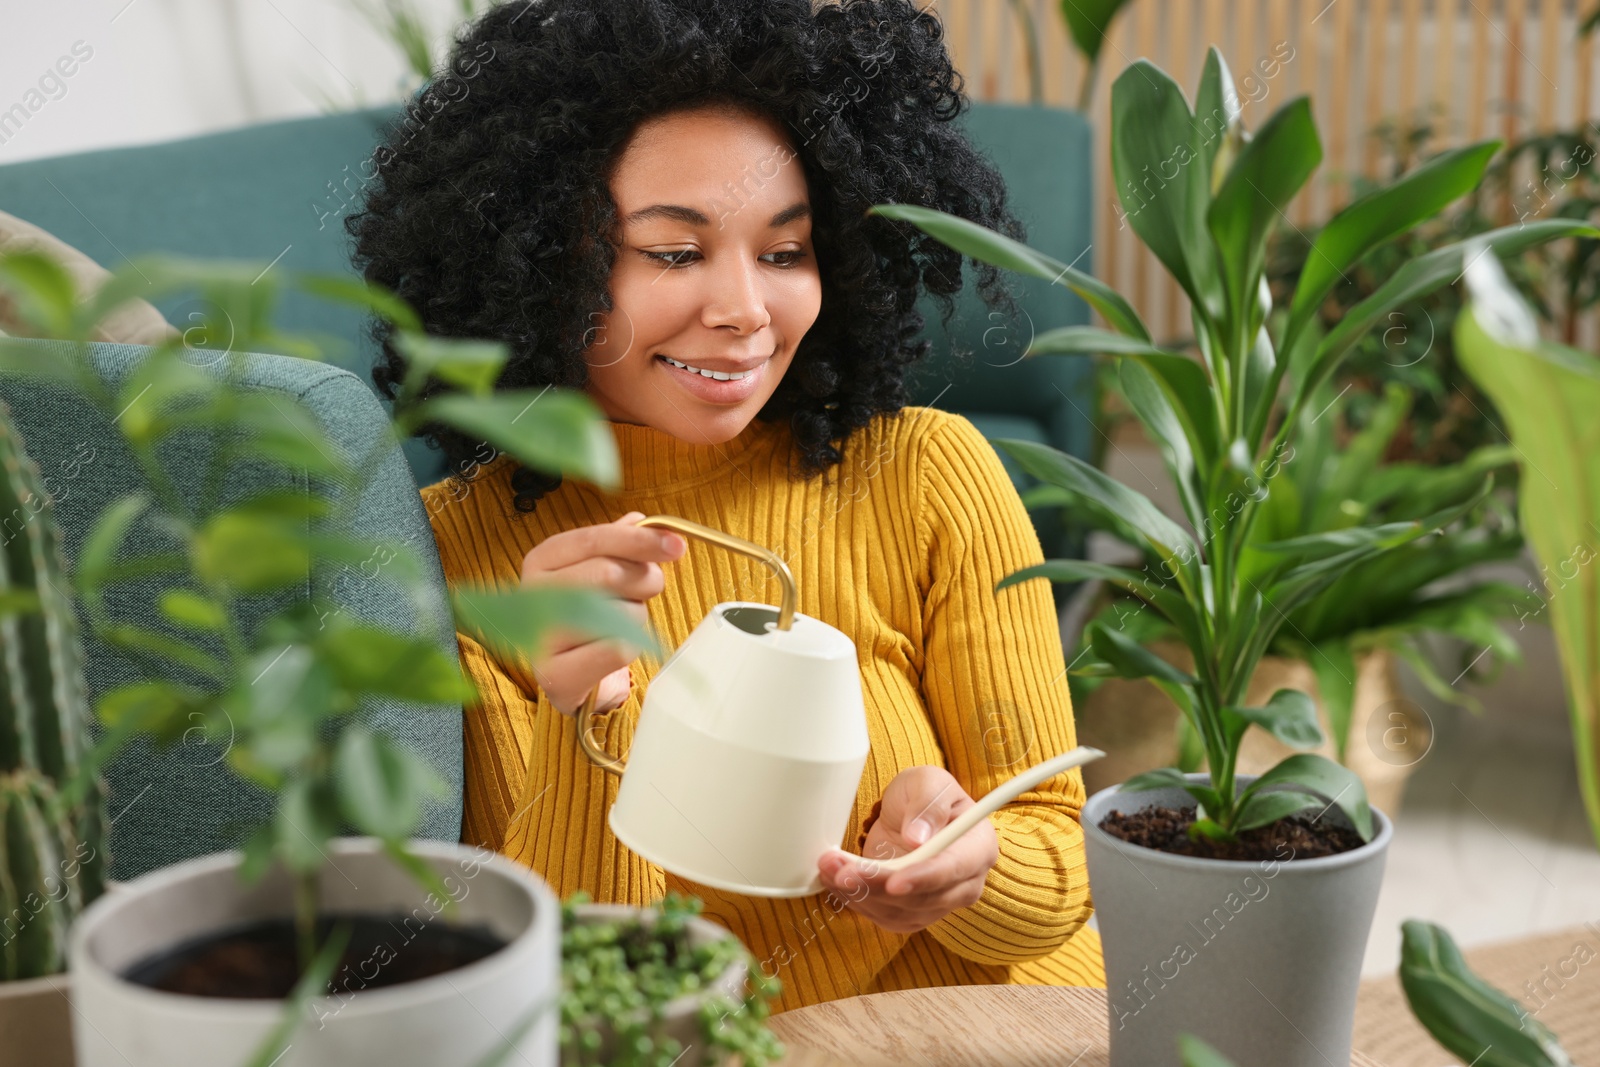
422;408;1106;1011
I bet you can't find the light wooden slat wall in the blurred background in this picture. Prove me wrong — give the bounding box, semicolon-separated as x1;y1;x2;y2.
928;0;1600;350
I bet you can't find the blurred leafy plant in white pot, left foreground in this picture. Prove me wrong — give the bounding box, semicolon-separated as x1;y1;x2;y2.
0;253;651;1067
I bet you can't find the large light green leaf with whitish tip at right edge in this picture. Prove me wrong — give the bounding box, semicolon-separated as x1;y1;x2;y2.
1454;256;1600;840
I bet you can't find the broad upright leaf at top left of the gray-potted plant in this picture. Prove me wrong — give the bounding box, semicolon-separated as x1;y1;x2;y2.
1110;59;1222;320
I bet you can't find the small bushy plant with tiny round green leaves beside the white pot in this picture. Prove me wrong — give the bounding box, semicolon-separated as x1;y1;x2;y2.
562;889;784;1067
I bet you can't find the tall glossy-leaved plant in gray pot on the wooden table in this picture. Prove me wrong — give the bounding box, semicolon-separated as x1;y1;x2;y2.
872;50;1594;1067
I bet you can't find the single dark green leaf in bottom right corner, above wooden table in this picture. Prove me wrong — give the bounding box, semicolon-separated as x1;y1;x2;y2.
1400;918;1573;1067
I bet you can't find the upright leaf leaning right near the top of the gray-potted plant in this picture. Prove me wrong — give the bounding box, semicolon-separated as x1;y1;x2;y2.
1206;96;1322;342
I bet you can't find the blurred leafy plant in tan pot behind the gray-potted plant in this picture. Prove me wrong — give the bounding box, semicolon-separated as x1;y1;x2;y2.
1058;375;1538;816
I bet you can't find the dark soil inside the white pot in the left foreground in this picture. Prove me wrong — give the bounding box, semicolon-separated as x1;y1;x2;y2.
123;913;506;1000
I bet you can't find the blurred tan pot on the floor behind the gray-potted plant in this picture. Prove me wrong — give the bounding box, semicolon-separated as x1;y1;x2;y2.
1077;641;1432;816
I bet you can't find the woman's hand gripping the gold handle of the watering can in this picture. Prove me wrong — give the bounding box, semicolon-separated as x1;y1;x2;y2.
522;512;688;715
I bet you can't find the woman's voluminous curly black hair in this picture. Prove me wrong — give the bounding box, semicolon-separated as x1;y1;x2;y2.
346;0;1026;510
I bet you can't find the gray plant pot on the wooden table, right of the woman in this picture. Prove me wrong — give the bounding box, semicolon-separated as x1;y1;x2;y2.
1082;774;1394;1067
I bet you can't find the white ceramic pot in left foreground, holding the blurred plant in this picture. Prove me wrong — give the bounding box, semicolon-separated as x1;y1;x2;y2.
69;838;562;1067
